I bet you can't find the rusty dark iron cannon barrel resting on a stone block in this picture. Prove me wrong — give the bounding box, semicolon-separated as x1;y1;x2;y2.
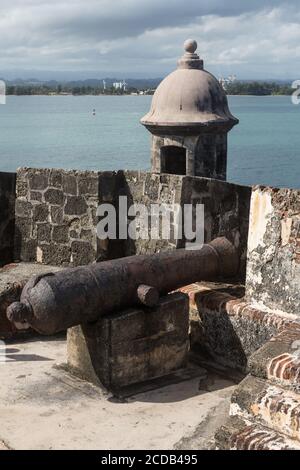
7;238;239;334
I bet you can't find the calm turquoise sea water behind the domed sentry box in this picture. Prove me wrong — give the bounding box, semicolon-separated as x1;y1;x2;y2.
0;96;300;188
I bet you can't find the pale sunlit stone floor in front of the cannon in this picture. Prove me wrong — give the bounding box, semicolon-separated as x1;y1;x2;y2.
0;337;235;450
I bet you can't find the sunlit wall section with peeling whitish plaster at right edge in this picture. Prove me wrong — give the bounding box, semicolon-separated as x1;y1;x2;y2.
246;187;300;315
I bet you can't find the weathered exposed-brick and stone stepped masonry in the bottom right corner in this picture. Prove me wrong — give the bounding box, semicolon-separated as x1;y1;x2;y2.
216;318;300;450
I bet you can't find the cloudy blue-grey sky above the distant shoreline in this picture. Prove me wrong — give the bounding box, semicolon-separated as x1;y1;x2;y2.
0;0;300;79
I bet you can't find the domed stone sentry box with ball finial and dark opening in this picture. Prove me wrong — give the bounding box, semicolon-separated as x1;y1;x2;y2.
141;39;239;180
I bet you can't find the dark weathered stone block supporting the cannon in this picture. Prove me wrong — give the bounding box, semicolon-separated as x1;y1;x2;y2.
68;294;188;390
